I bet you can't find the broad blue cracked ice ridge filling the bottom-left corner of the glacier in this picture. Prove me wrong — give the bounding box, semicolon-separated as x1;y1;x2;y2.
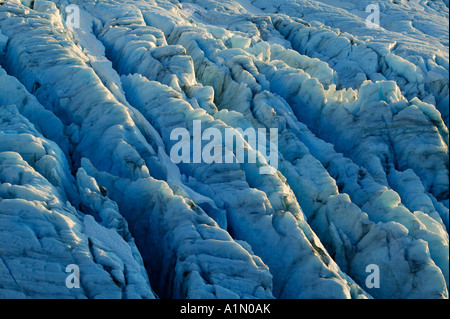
0;106;154;298
